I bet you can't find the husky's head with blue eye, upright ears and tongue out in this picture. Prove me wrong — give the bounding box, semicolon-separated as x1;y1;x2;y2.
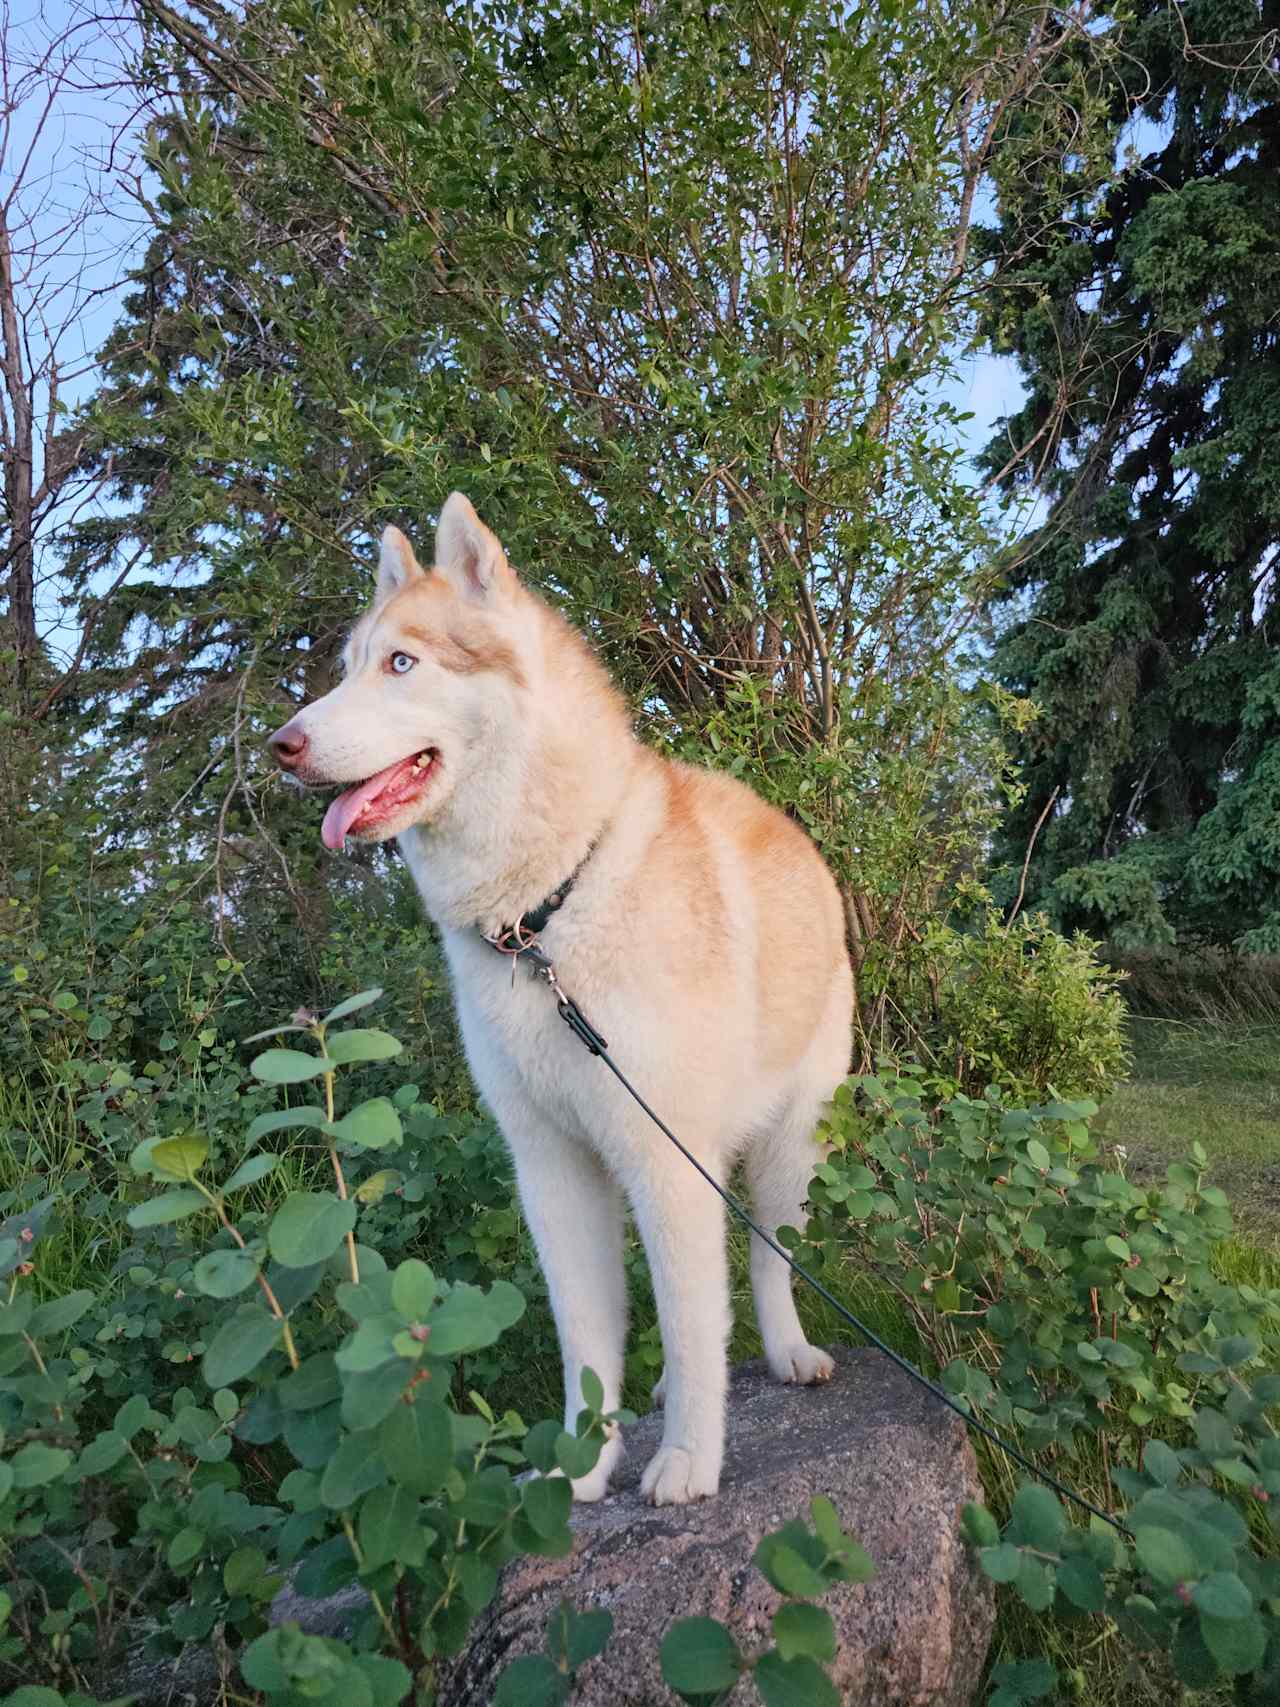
270;492;526;848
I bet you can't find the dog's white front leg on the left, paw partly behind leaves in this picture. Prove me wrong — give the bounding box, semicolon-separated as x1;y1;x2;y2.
509;1111;626;1500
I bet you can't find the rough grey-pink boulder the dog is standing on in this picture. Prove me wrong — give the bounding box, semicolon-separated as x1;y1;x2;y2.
437;1350;995;1707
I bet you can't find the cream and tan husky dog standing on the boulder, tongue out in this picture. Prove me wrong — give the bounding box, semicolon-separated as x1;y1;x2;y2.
271;492;853;1506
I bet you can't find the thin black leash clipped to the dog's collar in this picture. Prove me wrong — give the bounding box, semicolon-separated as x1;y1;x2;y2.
481;914;1133;1540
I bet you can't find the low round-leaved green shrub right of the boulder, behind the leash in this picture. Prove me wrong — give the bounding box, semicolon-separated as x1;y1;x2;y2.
794;1074;1280;1707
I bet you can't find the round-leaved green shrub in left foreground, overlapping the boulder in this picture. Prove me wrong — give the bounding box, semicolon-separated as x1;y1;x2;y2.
0;990;870;1707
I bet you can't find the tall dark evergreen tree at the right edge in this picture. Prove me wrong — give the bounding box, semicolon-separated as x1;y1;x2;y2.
986;0;1280;953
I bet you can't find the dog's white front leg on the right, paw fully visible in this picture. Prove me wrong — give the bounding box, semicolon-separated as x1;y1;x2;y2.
631;1152;730;1506
